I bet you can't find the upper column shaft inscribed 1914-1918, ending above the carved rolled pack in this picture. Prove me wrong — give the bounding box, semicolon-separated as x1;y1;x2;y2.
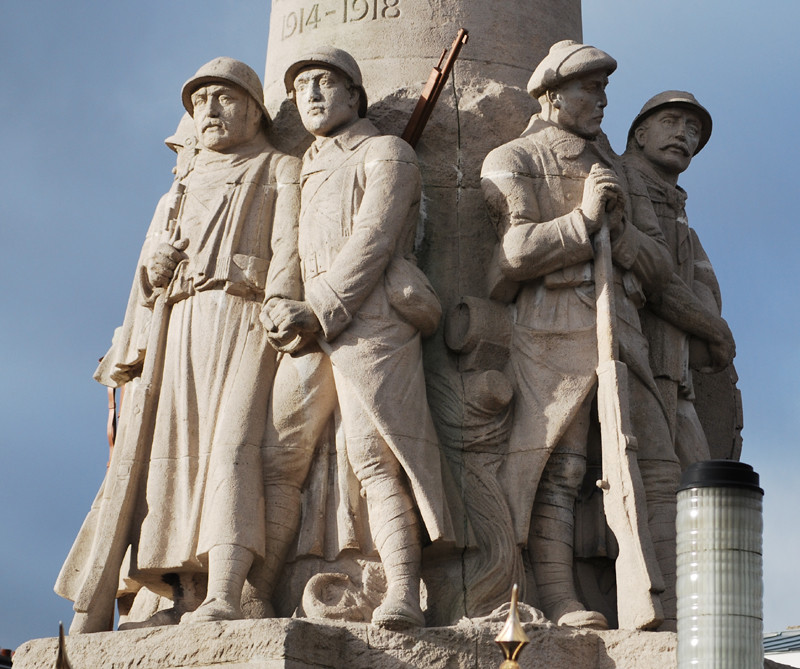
264;0;581;306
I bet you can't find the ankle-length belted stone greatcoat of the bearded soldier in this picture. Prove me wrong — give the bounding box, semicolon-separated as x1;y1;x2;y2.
56;135;299;600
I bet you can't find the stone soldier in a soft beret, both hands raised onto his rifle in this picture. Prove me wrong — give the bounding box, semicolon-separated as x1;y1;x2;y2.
481;40;680;628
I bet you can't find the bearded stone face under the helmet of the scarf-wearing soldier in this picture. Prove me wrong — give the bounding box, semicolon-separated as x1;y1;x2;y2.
192;84;261;152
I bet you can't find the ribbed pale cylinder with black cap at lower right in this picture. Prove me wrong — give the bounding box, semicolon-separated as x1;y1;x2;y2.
677;460;764;669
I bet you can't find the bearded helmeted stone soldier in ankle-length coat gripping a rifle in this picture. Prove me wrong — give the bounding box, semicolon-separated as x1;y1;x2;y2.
56;58;299;632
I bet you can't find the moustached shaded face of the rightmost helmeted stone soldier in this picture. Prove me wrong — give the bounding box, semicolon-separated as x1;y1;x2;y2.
634;107;703;176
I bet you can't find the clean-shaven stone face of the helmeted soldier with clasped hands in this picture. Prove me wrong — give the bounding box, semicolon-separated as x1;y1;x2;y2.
294;67;358;137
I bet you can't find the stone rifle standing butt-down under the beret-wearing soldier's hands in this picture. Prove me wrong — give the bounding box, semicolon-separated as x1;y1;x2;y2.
594;176;664;629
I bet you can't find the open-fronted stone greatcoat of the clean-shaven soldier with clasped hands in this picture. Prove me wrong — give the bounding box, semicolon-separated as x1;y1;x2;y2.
267;119;454;548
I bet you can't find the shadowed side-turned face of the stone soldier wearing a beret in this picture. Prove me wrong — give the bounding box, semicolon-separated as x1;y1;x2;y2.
551;72;608;139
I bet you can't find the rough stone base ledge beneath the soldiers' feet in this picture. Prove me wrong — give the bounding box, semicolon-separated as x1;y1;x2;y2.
14;619;784;669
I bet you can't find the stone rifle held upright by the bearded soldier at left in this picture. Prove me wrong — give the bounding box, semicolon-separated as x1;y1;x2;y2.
70;182;184;634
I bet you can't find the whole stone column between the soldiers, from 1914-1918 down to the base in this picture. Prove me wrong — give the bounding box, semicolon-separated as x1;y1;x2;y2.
264;0;581;623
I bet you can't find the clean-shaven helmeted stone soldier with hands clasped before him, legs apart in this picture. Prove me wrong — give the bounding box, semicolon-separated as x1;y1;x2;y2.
258;47;453;628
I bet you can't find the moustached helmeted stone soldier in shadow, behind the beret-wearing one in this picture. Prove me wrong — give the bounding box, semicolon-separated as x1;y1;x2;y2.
623;91;736;468
